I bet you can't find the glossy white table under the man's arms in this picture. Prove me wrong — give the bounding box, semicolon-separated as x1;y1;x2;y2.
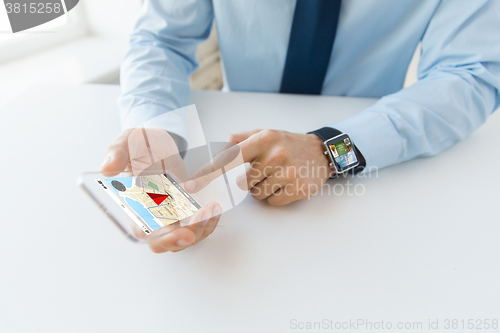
0;85;500;333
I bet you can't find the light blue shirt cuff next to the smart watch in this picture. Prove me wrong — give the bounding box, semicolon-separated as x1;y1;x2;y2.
332;110;403;171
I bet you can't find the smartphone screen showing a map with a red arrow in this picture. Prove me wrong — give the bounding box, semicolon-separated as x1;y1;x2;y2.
96;174;201;234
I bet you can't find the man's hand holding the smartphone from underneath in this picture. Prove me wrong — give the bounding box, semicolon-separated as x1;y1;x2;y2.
100;128;222;253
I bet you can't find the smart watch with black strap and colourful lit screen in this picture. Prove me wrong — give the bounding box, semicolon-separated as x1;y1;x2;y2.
308;127;366;178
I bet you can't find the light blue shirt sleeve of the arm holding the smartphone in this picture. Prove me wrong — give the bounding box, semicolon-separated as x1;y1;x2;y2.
118;0;213;147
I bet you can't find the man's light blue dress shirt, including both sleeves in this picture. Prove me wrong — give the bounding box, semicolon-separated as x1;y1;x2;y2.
119;0;500;168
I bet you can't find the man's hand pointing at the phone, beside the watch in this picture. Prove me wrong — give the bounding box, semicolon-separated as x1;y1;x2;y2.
185;129;332;205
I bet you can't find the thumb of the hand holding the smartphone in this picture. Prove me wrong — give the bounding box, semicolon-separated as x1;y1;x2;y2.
99;129;133;176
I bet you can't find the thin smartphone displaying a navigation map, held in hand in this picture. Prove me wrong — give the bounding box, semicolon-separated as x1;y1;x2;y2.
79;173;203;242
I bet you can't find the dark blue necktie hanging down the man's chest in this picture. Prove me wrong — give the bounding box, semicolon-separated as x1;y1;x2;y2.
280;0;341;95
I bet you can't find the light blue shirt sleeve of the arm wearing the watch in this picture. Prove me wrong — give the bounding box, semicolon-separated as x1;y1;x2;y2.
332;0;500;168
